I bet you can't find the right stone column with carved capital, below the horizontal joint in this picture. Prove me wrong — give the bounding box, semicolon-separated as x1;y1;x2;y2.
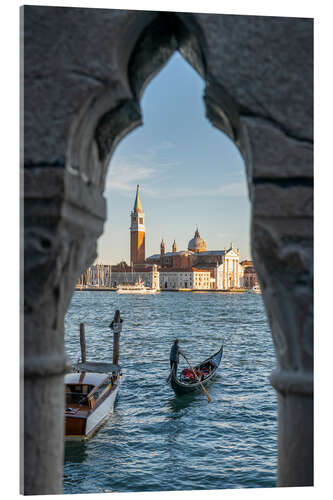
251;210;313;486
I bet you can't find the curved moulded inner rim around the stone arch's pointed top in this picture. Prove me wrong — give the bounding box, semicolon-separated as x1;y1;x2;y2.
67;12;246;195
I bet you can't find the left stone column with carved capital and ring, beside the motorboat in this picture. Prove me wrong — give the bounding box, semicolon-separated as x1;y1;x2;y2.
21;166;105;495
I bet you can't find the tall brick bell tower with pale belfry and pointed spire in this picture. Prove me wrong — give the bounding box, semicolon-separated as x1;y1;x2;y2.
130;184;146;265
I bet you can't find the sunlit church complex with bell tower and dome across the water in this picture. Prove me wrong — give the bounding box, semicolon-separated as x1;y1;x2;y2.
78;185;244;290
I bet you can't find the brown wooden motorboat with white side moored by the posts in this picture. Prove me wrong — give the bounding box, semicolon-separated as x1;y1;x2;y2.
65;362;122;441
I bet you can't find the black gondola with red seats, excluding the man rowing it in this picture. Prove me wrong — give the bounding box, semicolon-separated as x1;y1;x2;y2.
170;344;223;395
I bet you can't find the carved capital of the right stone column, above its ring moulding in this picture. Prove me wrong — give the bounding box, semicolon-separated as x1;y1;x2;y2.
252;218;313;373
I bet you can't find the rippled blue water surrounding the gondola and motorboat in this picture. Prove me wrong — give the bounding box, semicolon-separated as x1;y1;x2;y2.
64;292;277;493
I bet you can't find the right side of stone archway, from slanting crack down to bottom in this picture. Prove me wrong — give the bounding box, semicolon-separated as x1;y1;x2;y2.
244;118;313;486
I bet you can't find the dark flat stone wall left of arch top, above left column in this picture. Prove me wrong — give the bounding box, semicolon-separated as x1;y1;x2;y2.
22;6;149;170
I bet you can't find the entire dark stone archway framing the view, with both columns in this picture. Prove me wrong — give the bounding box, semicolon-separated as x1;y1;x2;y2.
21;7;313;494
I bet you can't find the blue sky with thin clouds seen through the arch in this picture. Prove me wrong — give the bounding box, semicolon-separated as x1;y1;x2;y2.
97;52;250;264
